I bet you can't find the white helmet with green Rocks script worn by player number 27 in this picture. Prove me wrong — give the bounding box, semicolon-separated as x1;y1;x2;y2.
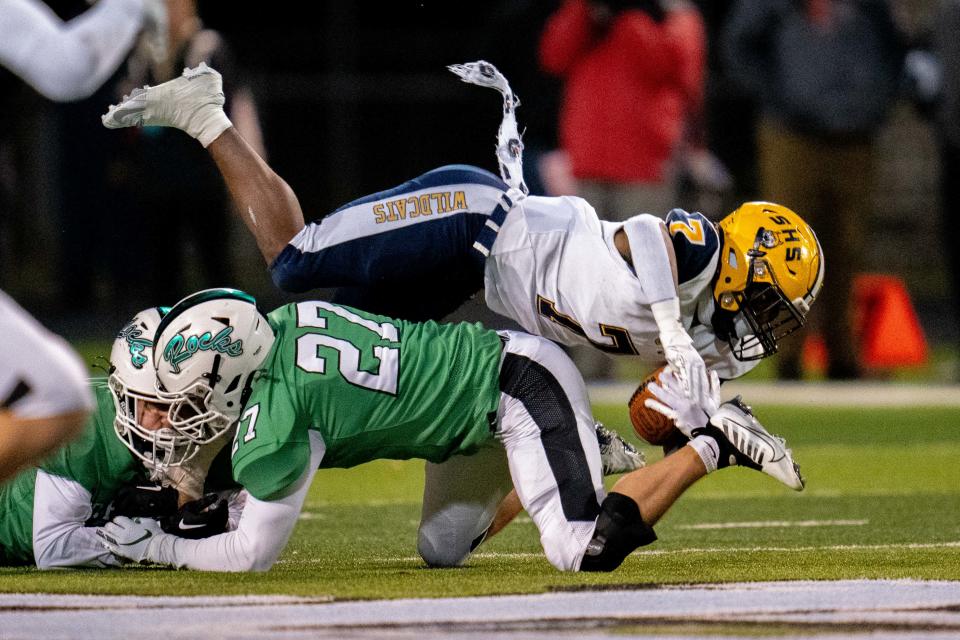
154;289;274;446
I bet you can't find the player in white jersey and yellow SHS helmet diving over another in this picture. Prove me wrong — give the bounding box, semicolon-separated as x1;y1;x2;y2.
103;63;823;398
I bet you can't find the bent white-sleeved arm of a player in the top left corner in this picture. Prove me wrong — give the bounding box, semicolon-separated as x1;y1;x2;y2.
0;0;144;102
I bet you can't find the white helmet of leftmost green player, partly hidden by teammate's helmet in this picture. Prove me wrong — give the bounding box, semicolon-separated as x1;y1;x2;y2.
107;307;188;479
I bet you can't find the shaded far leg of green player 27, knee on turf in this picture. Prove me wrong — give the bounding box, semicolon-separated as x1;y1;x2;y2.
417;444;513;567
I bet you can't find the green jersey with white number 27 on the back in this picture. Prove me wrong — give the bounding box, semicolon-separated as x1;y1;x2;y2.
233;301;502;499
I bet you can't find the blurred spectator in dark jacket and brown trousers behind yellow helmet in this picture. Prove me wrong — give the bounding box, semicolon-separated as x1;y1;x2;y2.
723;0;903;379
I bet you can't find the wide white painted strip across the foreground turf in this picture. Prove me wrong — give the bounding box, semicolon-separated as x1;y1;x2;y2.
0;580;960;640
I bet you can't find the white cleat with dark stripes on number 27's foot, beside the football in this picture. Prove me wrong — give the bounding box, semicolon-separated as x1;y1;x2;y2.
691;396;804;491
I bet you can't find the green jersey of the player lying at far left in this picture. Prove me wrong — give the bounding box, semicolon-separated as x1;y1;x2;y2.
0;380;142;565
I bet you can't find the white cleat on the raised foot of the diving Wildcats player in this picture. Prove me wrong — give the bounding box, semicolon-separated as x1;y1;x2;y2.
101;62;229;146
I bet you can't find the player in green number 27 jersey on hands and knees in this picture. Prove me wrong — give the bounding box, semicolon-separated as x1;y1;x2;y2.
100;289;804;571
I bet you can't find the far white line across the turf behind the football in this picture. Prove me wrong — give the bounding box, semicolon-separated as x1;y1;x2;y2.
587;380;960;407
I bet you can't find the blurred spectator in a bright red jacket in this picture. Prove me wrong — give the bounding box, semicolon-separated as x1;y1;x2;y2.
540;0;706;220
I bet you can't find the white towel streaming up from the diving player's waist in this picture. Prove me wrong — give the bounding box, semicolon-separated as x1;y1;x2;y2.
447;60;530;195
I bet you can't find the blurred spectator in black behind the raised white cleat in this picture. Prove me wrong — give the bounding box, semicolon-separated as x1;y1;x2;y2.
101;0;264;306
